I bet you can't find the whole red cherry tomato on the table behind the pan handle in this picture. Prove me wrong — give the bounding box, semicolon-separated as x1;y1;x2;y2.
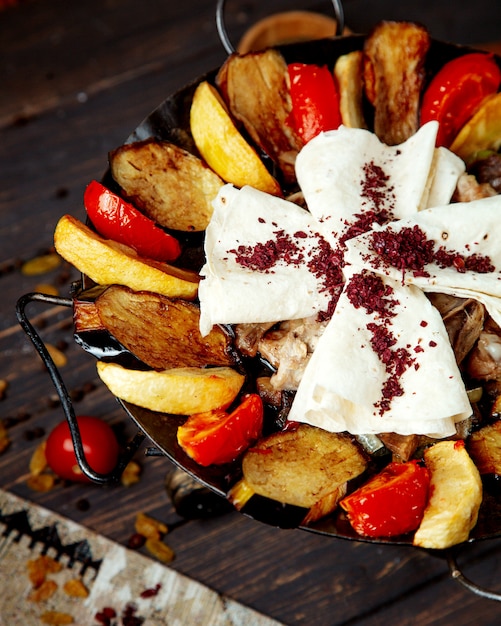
45;415;119;482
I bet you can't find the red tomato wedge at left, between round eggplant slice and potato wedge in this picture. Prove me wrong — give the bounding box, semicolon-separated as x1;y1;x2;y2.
84;180;181;261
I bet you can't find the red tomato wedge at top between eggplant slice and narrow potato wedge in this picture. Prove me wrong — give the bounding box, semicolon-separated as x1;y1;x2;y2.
287;63;342;143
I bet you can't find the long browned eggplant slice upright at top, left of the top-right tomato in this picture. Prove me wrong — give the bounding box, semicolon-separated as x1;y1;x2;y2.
364;22;430;145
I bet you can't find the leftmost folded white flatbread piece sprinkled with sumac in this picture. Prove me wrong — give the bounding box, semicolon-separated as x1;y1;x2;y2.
199;185;329;335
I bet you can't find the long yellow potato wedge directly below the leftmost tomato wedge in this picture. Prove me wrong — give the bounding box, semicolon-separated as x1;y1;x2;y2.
54;215;199;300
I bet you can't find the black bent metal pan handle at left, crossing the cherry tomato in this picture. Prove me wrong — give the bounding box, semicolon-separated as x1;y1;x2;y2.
16;293;145;485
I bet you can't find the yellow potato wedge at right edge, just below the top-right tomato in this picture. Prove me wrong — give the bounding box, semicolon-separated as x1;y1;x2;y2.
450;93;501;163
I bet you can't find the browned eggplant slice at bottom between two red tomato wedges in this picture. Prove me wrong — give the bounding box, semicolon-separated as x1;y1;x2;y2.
238;424;367;521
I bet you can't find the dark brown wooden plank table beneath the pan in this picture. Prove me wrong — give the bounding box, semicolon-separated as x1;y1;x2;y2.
0;0;501;626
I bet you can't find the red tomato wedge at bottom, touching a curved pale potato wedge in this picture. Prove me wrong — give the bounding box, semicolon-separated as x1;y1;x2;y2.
340;461;430;537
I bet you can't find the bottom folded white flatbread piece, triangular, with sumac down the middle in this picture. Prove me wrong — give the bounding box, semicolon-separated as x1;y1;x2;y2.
288;270;471;438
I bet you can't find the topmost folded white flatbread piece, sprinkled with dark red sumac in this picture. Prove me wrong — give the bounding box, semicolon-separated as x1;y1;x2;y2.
296;122;464;246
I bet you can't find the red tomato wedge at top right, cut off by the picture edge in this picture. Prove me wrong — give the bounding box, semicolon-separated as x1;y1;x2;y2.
421;52;501;148
